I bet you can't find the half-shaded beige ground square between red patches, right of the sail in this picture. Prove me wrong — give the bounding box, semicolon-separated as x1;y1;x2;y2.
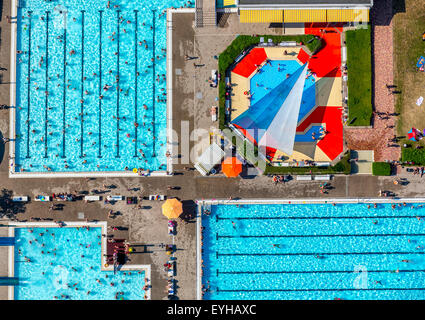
316;77;342;107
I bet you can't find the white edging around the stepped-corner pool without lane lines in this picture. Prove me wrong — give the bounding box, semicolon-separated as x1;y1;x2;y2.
8;221;152;300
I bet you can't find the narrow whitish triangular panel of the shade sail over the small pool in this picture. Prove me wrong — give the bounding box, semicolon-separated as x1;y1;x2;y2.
259;64;307;155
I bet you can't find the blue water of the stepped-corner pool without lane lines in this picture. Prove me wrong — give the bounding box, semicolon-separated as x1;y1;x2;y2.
15;227;145;300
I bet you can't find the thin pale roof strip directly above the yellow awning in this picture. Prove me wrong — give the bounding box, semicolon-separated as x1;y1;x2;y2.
239;0;373;7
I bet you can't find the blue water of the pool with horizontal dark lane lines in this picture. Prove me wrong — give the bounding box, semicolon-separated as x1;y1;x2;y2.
202;204;425;300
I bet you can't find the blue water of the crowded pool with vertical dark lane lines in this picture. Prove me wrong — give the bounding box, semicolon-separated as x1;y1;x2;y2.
15;0;194;172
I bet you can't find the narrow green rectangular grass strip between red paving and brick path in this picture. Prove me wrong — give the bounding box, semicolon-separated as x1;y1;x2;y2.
346;26;372;126
